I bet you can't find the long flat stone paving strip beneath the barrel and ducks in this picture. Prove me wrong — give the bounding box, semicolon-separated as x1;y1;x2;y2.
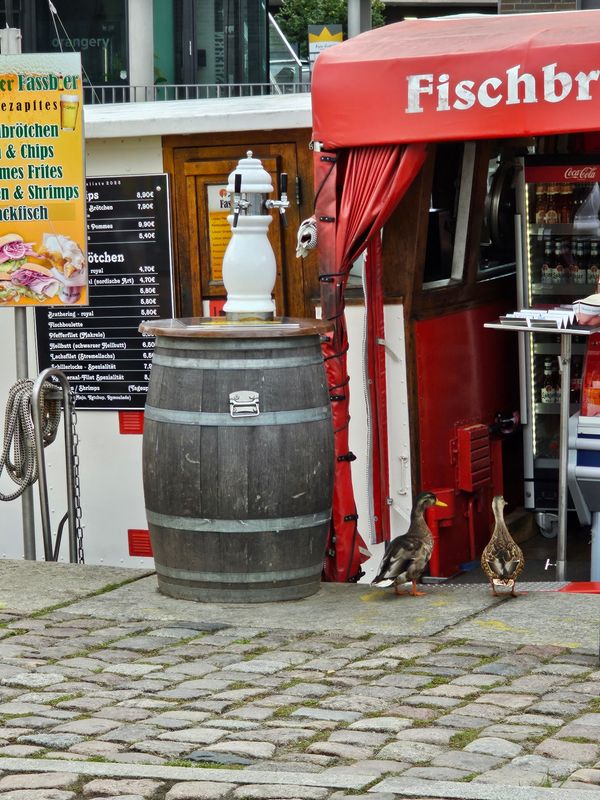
58;569;600;650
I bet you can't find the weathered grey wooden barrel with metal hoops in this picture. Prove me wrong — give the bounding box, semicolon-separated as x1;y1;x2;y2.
140;320;334;603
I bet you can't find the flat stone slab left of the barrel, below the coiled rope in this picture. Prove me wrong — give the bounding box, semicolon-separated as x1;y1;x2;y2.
0;559;149;614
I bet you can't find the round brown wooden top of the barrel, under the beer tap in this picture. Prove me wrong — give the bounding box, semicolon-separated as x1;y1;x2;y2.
138;317;333;339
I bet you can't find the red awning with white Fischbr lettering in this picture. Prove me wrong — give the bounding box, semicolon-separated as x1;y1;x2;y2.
312;11;600;149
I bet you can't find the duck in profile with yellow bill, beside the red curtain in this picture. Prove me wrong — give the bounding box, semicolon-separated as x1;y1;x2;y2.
371;492;447;597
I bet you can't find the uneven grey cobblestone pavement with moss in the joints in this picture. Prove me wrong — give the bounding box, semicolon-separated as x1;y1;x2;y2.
0;576;600;800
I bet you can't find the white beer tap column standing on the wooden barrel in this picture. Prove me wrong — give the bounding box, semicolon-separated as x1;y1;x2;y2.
223;150;289;321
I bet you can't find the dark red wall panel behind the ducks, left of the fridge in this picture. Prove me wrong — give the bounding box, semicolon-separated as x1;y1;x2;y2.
414;304;519;576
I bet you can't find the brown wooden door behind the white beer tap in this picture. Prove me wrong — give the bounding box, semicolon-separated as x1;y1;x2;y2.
167;134;318;317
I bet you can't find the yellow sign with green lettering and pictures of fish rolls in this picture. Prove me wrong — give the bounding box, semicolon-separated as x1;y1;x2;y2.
0;53;88;308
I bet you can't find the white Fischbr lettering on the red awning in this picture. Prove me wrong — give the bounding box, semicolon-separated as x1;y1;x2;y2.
406;63;600;114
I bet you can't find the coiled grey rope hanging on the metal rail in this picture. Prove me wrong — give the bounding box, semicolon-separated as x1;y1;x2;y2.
0;380;61;501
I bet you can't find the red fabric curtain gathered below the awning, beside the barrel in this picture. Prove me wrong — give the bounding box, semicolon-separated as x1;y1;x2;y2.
315;144;426;581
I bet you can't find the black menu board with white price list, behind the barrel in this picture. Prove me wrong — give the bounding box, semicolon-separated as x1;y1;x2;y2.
35;174;173;410
